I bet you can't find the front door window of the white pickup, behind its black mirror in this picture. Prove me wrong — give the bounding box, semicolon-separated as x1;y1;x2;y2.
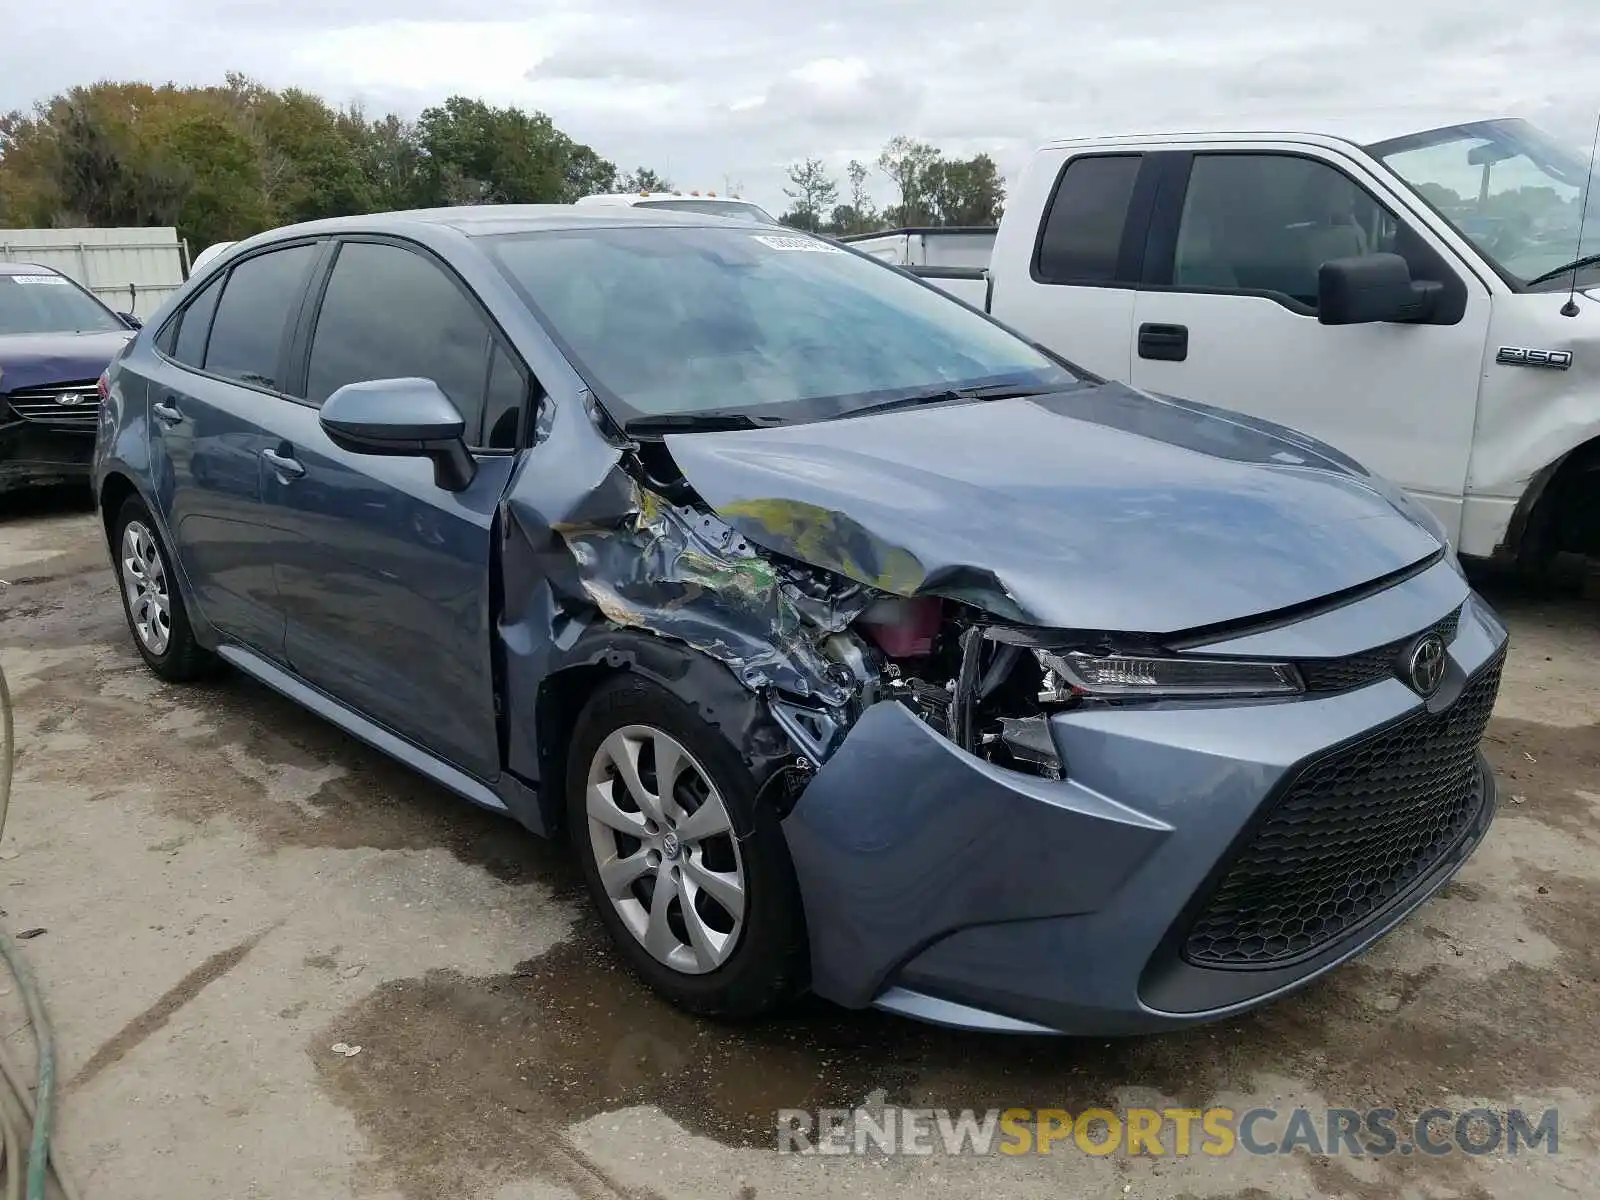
1173;154;1400;307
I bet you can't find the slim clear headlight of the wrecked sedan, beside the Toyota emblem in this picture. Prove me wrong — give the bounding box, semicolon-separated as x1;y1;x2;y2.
1034;650;1306;701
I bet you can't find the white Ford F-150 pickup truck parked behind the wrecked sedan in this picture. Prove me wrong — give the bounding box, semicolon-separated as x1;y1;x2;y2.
907;120;1600;568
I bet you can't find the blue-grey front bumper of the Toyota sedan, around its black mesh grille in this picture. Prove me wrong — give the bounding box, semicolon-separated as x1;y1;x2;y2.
784;568;1506;1035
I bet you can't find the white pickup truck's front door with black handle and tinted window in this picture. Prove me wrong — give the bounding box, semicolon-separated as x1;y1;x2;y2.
1133;144;1491;538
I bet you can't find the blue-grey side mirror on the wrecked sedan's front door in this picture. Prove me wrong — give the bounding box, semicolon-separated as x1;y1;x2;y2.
320;379;477;491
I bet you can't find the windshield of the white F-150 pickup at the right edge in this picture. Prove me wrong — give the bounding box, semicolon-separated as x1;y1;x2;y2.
1368;120;1600;286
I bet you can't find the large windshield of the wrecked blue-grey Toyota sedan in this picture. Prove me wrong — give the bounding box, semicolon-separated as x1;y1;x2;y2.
490;226;1074;421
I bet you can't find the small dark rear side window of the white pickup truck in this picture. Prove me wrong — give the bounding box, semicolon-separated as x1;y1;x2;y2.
1035;154;1142;283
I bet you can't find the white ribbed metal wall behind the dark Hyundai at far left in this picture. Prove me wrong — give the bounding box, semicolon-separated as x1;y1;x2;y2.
0;226;189;320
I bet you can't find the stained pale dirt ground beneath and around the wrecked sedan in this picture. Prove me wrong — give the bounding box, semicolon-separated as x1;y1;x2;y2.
0;498;1600;1200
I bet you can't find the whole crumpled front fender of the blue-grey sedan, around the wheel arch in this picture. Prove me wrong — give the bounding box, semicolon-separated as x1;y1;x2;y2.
496;396;874;826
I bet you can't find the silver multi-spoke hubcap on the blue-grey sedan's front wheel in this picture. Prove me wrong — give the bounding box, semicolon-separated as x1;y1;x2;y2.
586;725;746;974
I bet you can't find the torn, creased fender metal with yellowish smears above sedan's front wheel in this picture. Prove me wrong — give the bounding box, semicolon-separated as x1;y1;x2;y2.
555;480;869;707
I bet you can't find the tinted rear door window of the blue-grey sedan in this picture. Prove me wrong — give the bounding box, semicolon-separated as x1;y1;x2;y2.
203;243;318;390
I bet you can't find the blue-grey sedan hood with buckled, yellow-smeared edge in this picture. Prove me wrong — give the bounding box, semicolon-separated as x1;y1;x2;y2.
666;384;1442;634
